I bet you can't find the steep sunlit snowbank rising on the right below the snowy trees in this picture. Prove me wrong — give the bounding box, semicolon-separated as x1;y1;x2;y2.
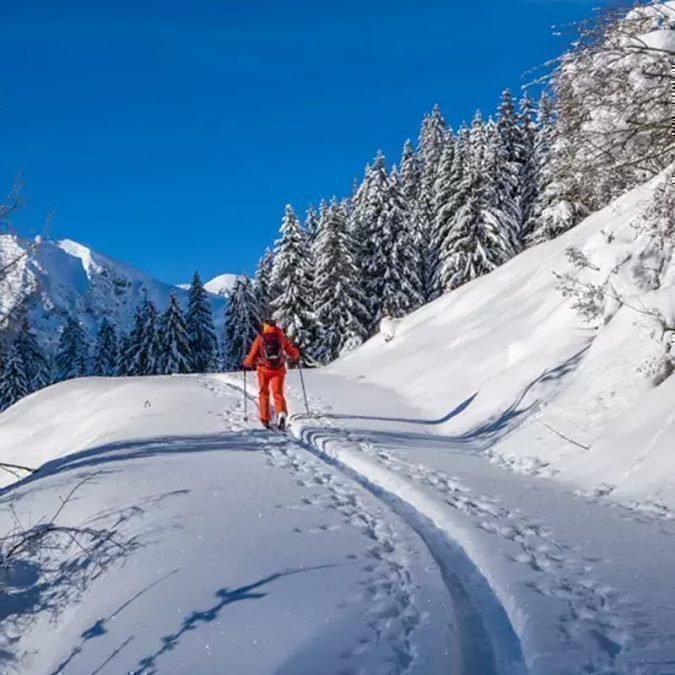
329;174;675;508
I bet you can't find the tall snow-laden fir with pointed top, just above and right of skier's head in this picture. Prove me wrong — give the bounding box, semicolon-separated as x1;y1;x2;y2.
271;205;317;354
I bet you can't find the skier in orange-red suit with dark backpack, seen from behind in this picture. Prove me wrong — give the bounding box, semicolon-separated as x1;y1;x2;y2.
243;319;300;431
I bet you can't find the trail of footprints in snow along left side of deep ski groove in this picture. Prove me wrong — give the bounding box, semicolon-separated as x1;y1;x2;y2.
202;379;422;675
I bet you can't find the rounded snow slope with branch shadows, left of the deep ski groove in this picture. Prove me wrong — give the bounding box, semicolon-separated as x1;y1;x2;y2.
0;377;454;675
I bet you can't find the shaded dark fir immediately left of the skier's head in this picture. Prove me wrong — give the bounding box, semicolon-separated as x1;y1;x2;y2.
223;274;262;370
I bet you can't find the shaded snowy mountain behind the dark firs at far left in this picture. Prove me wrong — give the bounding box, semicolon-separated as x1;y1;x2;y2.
0;235;223;347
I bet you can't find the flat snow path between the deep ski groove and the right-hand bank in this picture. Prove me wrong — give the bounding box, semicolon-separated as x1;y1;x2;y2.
213;373;675;675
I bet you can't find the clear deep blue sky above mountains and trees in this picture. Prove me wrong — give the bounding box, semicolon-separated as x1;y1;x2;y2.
0;0;599;282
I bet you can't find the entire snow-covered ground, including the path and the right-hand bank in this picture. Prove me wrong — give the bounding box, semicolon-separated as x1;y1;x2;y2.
0;172;675;675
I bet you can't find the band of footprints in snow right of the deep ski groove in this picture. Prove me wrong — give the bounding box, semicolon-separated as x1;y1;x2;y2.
286;386;644;675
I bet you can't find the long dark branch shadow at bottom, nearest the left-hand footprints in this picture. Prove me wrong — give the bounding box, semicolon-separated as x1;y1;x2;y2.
130;565;336;675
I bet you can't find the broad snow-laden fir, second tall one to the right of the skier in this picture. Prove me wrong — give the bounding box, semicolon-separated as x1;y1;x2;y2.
314;199;368;363
